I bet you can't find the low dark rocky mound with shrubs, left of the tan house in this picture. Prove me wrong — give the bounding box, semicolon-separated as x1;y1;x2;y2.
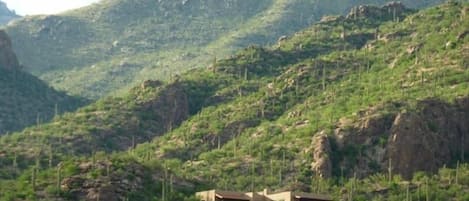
59;159;195;201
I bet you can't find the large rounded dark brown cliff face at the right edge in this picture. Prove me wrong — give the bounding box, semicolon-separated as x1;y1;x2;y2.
387;99;469;178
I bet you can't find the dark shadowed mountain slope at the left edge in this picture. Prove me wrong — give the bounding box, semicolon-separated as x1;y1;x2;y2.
0;31;85;134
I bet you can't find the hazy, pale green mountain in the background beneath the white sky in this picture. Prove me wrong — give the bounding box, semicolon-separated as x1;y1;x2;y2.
7;0;442;99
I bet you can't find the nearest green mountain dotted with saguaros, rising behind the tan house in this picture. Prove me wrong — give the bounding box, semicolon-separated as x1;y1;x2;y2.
0;1;469;201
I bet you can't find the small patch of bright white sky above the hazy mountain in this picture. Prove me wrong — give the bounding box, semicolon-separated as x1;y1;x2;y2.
2;0;100;15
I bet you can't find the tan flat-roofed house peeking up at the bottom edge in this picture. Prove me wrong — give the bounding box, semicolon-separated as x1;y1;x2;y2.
196;190;332;201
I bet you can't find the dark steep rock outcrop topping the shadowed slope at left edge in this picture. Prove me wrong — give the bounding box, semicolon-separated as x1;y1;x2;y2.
0;30;21;70
